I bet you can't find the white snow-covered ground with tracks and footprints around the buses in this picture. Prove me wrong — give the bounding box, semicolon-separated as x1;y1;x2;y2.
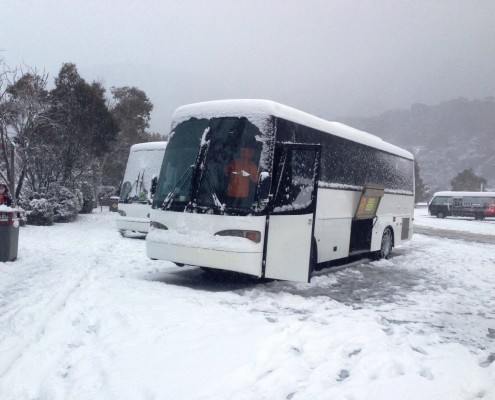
0;211;495;400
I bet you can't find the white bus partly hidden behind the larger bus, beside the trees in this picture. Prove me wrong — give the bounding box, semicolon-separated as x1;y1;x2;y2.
115;142;167;236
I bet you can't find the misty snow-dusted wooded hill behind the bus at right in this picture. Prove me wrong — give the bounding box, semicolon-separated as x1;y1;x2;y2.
339;97;495;191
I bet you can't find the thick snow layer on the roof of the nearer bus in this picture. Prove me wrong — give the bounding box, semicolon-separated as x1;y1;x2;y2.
172;99;414;160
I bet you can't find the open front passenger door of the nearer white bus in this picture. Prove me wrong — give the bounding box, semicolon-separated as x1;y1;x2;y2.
264;144;321;282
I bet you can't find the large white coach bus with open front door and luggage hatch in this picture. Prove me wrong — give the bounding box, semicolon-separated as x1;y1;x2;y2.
146;100;414;282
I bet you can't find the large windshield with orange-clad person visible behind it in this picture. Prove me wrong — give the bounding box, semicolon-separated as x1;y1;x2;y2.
153;117;262;213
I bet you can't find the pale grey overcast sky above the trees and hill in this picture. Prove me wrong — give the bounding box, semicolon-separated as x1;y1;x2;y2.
0;0;495;133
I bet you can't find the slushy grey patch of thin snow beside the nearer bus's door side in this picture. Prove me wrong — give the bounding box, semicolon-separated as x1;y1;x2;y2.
235;234;495;354
